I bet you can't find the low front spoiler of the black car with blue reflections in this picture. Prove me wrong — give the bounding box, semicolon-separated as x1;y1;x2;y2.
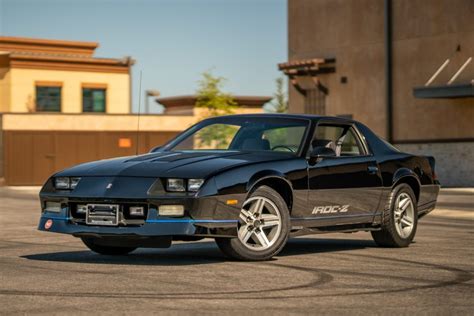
38;214;237;237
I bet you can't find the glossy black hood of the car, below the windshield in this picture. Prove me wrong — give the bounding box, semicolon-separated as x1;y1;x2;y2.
56;151;294;178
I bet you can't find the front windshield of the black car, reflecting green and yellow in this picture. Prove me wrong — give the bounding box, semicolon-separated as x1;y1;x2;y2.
163;116;309;154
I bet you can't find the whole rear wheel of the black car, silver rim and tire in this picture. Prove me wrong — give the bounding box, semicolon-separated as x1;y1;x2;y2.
372;183;418;247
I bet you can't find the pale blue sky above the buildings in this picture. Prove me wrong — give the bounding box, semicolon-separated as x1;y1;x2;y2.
0;0;287;113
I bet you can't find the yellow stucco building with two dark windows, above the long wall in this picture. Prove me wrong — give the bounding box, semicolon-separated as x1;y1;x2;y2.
0;36;133;114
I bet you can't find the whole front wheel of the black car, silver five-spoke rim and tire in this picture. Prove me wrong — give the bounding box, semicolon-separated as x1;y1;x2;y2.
216;186;290;261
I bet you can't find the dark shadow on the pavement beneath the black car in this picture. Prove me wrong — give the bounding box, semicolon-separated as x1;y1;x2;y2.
21;238;375;266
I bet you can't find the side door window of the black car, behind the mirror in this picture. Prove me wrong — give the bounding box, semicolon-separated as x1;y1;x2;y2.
311;125;364;157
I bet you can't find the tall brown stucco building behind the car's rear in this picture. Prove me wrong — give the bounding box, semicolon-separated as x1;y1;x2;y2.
279;0;474;186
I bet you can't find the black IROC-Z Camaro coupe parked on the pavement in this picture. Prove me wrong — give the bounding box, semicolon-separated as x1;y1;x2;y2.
39;114;439;260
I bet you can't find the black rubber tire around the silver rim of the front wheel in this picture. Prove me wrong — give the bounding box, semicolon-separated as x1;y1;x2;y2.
216;186;290;261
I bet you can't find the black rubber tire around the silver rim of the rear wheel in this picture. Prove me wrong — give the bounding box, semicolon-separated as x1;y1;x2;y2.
371;183;418;248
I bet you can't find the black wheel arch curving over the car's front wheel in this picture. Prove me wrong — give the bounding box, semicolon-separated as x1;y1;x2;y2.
247;170;293;213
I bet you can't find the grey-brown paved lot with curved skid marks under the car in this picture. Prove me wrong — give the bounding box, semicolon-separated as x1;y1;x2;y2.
0;187;474;315
